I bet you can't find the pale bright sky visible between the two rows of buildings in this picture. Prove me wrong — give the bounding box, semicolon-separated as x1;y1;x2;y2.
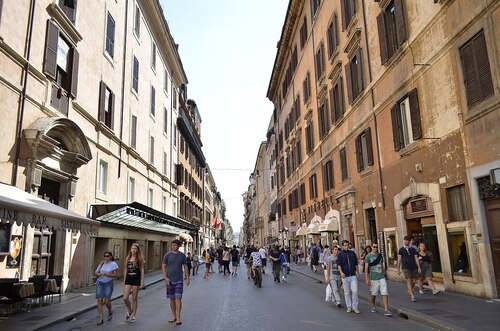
160;0;288;232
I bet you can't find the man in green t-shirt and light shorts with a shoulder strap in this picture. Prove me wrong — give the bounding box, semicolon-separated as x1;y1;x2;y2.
365;243;392;316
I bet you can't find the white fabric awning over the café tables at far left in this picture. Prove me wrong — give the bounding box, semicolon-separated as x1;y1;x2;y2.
0;183;100;234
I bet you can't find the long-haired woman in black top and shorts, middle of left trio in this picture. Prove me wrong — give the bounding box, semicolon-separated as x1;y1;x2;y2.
123;243;144;322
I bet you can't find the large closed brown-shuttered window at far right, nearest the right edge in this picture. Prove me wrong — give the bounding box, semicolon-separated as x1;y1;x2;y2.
460;30;494;107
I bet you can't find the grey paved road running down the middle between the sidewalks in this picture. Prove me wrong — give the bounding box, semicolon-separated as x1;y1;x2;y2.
48;270;429;331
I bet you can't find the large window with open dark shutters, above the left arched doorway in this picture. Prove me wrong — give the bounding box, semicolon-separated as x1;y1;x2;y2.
43;20;80;115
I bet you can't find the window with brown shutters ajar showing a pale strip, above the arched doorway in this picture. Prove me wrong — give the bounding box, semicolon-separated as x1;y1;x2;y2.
391;89;422;151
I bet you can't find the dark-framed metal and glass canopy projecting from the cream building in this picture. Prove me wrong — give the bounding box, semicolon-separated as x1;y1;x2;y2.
91;202;198;236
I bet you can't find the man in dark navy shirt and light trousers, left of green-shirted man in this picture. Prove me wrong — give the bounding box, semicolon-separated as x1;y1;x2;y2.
337;240;360;314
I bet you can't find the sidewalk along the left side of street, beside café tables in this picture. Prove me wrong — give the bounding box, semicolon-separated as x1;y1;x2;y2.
0;270;163;331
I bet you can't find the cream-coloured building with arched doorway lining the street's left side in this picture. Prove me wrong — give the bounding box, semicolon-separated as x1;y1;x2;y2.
0;0;201;287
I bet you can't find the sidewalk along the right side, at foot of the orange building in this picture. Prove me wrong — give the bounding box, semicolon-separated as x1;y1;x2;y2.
290;263;500;330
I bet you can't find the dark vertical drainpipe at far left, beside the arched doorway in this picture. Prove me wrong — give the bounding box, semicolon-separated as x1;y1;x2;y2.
11;0;36;186
